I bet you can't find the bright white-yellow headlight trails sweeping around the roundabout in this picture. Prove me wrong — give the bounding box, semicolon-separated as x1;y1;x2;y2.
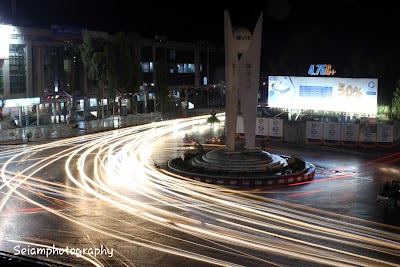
0;116;400;266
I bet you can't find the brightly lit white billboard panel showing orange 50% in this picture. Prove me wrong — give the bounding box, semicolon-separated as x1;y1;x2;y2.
268;76;378;114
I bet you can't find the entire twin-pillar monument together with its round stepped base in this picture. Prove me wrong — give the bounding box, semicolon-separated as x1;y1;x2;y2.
168;10;315;185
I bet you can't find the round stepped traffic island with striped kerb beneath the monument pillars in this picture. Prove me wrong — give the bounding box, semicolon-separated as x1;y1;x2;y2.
165;148;315;186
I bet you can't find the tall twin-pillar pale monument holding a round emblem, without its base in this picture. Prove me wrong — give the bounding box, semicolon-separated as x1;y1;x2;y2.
224;10;263;151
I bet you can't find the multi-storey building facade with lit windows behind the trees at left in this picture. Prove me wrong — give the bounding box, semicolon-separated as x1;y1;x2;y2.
0;25;224;126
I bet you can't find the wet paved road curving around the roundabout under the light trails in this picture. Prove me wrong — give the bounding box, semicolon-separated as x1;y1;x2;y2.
0;110;400;266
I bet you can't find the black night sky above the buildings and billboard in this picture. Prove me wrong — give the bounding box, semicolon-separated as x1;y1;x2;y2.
0;0;400;102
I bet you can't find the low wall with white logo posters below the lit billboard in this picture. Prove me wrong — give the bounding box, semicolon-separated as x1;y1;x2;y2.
236;116;400;147
